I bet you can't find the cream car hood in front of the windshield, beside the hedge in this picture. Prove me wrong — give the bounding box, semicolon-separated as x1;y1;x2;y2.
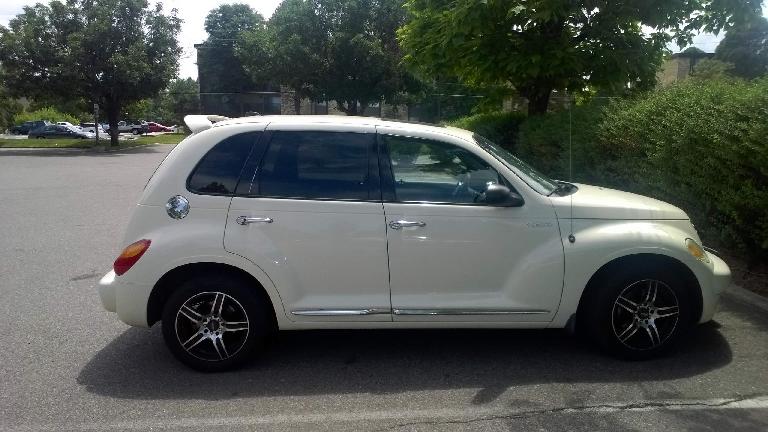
551;183;688;220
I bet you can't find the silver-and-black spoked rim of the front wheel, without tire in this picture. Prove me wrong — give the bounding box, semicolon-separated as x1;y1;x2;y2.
611;279;680;351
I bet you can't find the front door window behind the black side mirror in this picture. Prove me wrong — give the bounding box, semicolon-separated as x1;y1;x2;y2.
382;135;509;205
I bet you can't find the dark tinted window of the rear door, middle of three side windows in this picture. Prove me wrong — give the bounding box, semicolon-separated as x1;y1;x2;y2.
258;131;375;200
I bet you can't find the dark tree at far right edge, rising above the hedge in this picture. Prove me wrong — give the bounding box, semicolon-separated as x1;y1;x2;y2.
715;16;768;79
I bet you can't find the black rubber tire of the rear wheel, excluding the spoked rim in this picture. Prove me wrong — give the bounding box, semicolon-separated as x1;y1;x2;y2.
162;276;274;372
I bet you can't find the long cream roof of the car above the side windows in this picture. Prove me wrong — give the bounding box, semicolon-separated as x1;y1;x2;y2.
211;115;471;137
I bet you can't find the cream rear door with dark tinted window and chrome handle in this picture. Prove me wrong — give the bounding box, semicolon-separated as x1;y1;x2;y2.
224;125;392;322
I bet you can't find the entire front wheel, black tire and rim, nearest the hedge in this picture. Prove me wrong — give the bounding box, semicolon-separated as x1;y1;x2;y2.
577;266;695;360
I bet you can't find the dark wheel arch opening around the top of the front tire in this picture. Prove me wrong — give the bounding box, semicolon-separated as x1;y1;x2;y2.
574;253;704;324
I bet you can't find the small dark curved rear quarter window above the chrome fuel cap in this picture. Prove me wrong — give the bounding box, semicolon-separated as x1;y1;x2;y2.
187;132;259;195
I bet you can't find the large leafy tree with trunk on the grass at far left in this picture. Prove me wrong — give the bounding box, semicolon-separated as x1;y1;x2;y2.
0;0;181;146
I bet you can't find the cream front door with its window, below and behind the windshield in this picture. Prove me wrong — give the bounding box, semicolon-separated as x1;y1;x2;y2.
379;128;564;323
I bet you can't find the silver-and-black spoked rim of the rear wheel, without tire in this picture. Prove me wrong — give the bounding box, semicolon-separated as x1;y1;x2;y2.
175;292;250;361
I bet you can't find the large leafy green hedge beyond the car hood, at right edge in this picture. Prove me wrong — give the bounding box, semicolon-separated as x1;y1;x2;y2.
598;79;768;259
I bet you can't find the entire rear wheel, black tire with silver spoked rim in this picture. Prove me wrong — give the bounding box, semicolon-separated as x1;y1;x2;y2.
162;275;275;372
